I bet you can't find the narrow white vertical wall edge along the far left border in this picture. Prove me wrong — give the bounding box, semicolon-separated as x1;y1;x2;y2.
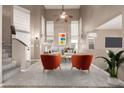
0;6;2;84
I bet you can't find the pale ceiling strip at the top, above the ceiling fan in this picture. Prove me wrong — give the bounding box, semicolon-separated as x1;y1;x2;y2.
45;5;80;9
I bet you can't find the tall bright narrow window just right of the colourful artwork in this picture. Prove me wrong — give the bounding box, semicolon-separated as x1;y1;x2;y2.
71;21;79;50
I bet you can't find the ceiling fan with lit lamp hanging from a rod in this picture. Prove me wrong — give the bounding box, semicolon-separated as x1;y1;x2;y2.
55;5;73;22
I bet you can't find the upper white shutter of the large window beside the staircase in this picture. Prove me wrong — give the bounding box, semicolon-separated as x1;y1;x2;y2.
13;6;30;32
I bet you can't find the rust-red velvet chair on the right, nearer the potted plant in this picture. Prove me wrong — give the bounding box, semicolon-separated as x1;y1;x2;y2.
71;55;93;72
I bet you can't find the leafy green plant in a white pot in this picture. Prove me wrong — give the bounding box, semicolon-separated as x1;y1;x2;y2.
96;50;124;84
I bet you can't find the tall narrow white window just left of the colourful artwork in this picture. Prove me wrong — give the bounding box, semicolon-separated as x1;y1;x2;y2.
46;21;54;42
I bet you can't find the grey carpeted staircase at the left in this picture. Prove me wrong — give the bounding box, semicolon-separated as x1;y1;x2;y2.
2;42;20;82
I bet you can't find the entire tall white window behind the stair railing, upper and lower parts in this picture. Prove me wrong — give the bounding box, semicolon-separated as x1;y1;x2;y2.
13;6;31;60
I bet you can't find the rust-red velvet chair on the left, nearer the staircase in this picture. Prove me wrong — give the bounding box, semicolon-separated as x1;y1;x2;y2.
41;54;61;72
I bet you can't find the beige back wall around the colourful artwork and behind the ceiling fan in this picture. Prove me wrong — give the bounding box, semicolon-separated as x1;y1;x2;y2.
45;9;79;47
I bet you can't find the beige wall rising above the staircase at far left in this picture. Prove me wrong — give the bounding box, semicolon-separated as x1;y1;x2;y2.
2;5;13;45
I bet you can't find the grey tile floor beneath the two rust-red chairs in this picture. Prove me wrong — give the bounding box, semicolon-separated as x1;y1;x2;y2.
3;62;124;88
